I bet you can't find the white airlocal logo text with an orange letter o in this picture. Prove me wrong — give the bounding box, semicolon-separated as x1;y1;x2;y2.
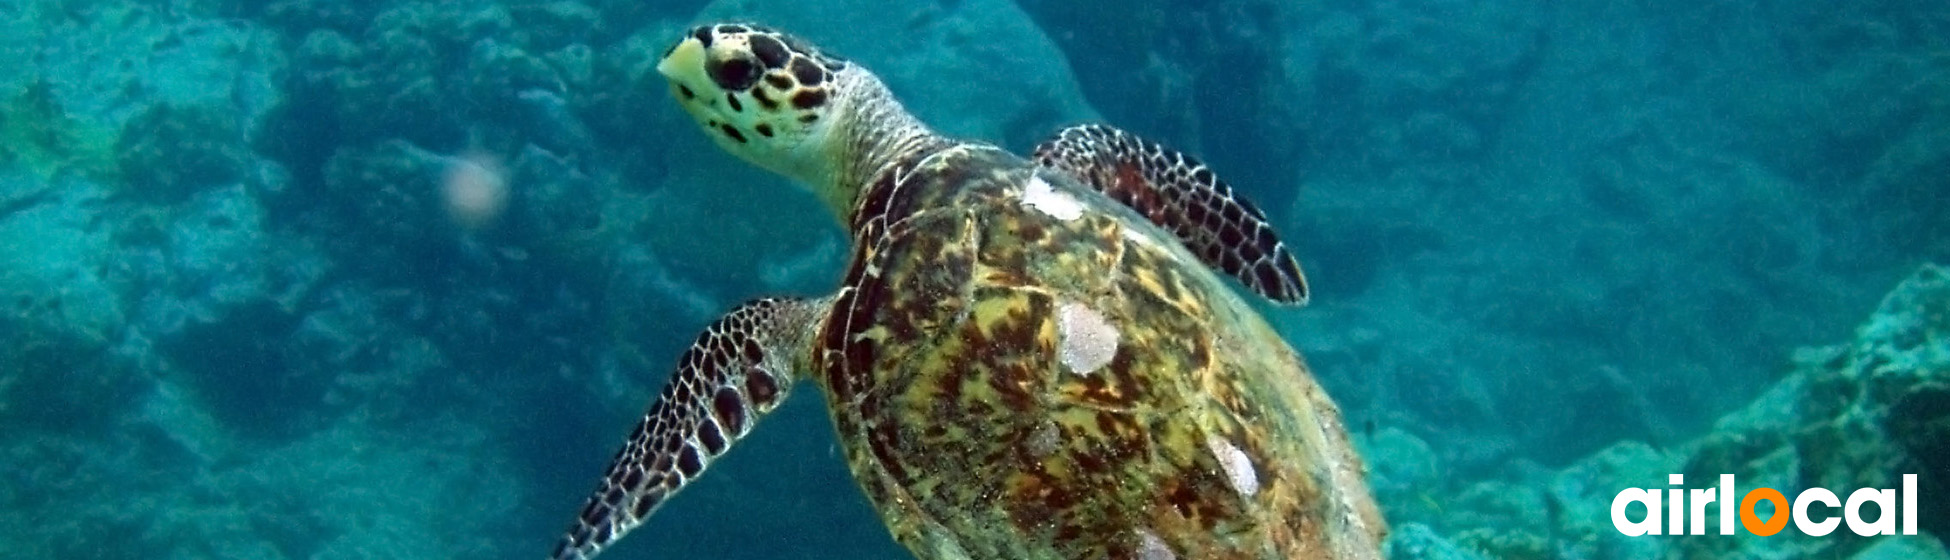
1611;474;1917;537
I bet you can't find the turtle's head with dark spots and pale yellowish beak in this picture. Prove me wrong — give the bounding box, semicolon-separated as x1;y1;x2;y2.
657;23;870;206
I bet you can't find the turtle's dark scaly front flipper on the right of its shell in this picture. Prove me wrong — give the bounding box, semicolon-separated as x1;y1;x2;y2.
1034;125;1307;304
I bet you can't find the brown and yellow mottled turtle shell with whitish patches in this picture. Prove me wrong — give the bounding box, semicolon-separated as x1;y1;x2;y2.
813;144;1385;558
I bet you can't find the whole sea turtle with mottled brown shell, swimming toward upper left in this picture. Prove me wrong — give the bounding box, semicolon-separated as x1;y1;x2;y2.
552;23;1385;560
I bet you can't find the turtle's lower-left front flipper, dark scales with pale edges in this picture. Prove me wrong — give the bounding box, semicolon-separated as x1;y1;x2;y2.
550;299;827;560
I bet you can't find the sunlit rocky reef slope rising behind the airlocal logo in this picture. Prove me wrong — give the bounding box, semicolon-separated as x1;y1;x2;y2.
1365;265;1950;560
